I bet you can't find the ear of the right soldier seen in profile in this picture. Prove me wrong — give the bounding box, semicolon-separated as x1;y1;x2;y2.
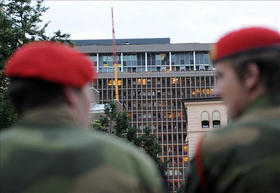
244;63;260;90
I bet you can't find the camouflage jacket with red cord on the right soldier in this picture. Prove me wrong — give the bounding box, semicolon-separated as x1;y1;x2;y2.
185;95;280;193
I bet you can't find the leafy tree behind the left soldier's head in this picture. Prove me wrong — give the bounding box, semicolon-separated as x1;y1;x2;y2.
0;0;72;129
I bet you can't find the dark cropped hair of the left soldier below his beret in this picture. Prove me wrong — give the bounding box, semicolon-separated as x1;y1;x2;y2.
8;78;79;116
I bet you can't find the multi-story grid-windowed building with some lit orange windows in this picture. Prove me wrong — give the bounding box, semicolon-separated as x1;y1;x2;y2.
74;38;216;192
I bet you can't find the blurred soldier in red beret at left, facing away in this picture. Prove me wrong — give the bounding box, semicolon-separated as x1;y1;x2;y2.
0;41;166;193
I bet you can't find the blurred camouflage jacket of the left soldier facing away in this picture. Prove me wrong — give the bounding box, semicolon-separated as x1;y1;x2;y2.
0;105;163;193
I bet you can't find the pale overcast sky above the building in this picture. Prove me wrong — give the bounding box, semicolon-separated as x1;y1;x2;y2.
43;1;280;43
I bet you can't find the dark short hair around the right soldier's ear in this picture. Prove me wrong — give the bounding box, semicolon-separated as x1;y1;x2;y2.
225;49;280;92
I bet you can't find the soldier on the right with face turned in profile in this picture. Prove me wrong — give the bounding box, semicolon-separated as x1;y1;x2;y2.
185;27;280;193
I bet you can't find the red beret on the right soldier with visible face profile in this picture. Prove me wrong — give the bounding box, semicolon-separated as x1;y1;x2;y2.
210;27;280;62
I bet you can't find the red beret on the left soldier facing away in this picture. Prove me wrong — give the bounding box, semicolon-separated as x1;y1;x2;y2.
4;41;97;87
